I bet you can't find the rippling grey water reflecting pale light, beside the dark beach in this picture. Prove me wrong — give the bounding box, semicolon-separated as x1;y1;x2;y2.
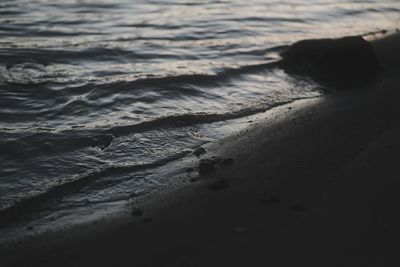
0;0;400;234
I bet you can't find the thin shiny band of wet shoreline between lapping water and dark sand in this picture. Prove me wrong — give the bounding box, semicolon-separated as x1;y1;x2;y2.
0;96;323;247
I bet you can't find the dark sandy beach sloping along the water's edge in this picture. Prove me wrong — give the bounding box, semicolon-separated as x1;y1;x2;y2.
0;34;400;267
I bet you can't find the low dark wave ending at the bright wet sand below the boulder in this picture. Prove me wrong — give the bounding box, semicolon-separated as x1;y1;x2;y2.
0;98;310;160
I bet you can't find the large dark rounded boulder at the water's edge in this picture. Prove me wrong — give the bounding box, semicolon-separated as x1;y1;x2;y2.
281;36;378;88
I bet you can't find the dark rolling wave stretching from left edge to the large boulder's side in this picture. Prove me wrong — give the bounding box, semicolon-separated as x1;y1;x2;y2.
0;62;279;121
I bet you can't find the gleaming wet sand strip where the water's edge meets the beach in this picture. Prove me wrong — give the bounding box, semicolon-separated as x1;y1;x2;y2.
0;95;322;244
